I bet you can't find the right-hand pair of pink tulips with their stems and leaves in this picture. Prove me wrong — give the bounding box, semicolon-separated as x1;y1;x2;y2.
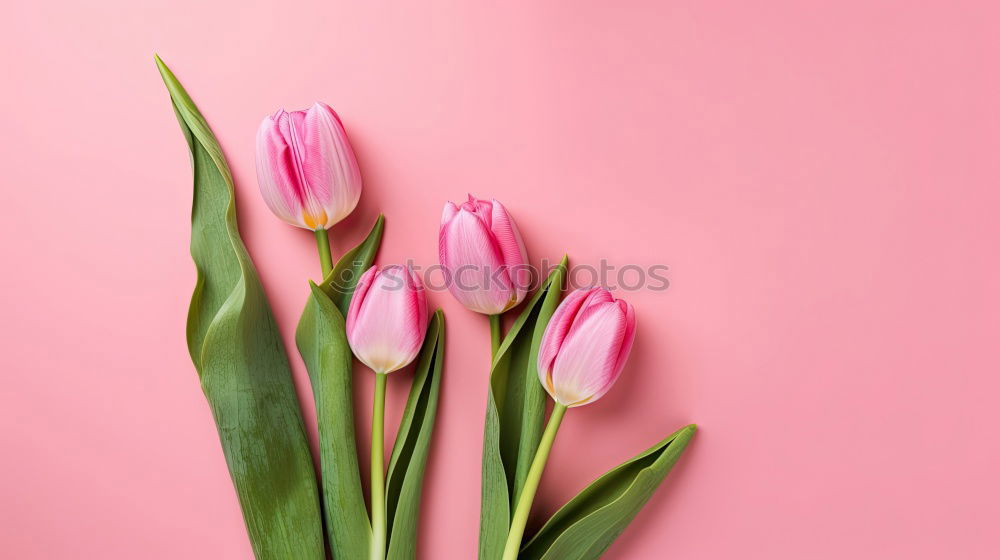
438;196;696;560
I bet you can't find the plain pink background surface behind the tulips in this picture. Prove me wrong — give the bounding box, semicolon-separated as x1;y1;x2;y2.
0;0;1000;560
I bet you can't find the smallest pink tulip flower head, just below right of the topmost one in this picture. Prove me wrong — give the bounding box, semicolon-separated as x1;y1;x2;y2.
347;265;429;373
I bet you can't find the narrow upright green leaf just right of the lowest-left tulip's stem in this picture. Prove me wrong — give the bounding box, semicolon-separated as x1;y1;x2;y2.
386;309;444;560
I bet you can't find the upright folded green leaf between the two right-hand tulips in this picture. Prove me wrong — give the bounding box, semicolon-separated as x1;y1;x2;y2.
479;257;568;560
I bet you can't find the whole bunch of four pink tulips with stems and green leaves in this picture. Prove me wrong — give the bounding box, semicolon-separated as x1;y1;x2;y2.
156;53;695;560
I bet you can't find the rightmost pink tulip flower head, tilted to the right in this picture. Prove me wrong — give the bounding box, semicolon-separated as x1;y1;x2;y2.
538;288;635;407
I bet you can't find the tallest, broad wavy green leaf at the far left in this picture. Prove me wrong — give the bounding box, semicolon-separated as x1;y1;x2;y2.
156;53;324;560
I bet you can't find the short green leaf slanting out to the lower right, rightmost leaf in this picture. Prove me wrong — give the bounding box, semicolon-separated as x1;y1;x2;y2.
518;424;697;560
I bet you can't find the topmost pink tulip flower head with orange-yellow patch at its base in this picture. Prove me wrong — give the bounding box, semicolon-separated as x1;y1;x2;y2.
257;103;361;231
